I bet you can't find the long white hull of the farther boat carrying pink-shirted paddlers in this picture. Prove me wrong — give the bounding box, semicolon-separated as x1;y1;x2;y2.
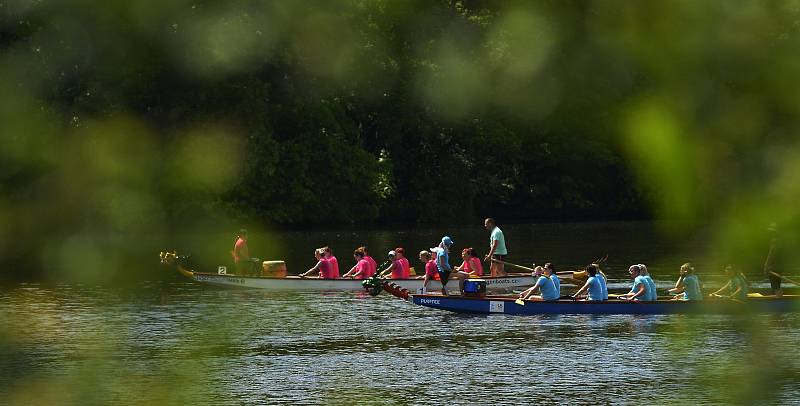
178;267;534;292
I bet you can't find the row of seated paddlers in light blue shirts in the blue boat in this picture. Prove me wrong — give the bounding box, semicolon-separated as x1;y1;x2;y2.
520;263;748;301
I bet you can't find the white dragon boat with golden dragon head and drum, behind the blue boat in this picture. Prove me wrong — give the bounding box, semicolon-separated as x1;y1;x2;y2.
160;252;552;293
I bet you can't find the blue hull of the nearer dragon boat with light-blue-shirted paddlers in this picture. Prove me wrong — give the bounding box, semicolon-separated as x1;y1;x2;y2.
409;295;800;315
